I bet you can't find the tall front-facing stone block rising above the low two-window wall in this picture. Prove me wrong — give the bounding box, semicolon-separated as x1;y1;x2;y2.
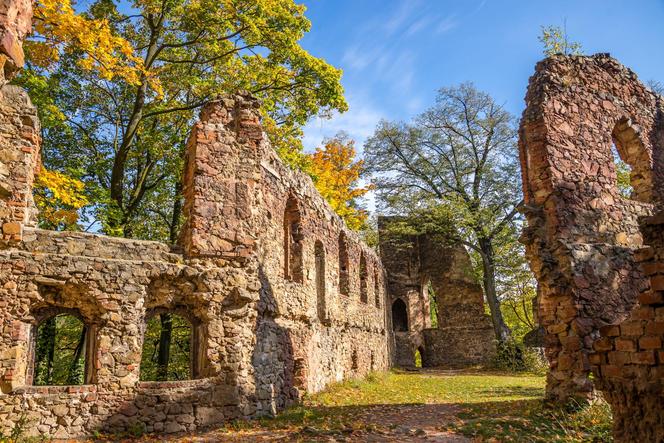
180;94;267;259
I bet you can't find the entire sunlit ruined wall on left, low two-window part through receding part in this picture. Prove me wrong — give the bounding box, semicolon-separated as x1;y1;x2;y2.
0;94;390;438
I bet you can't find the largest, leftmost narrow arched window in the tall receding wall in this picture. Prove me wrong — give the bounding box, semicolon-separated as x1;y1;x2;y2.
284;196;304;283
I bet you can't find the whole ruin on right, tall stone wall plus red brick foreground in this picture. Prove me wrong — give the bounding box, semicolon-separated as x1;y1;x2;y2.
519;54;664;441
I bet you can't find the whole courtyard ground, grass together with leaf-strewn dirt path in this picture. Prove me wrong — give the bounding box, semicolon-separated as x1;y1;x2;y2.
65;369;612;443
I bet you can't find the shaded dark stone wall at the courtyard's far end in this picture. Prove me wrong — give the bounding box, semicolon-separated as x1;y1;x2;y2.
379;224;496;367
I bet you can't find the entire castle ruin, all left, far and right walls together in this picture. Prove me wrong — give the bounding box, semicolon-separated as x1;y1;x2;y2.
0;0;664;441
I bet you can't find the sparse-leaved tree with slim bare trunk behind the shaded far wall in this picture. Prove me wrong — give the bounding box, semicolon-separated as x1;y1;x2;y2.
365;83;521;342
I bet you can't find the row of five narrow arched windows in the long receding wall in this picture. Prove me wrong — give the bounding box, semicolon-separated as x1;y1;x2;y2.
284;197;380;310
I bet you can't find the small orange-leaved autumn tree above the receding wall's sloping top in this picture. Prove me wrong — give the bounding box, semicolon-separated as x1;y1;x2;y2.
309;133;370;230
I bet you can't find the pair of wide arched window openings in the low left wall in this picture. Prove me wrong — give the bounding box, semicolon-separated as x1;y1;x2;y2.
28;312;200;386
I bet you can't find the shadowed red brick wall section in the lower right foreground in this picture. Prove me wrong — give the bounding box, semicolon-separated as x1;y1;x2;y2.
590;212;664;442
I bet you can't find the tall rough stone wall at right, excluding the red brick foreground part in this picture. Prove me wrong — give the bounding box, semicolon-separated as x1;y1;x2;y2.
519;54;664;402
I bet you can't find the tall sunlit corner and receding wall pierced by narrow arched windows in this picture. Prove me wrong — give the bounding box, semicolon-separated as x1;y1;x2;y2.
184;96;389;392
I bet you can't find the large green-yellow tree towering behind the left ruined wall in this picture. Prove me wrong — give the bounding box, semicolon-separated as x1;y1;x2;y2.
20;0;347;241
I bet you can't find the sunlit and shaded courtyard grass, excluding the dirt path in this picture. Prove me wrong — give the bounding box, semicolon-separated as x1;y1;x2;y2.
252;371;611;442
